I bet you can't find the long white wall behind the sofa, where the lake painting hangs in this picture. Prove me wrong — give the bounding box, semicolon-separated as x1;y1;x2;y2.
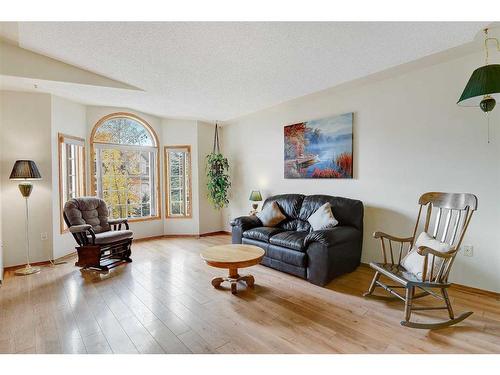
224;53;500;292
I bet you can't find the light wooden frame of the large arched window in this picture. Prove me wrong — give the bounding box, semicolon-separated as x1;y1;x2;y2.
90;112;162;222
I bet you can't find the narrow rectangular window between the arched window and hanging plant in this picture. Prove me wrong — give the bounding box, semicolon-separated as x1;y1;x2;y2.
165;146;191;218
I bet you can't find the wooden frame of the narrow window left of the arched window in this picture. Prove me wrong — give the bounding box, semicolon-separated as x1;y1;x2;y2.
57;133;87;234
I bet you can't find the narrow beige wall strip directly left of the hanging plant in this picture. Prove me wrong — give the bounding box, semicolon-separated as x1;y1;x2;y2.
198;121;224;234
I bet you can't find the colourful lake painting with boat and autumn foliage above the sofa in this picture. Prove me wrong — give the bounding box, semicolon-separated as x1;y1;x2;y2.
285;113;353;178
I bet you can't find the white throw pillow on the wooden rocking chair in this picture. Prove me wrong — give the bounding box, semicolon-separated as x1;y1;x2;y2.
401;232;451;279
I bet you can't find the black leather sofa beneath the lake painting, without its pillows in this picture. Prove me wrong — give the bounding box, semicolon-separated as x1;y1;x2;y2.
231;194;363;285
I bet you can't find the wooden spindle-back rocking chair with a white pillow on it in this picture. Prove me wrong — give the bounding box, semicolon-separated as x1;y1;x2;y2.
364;193;477;329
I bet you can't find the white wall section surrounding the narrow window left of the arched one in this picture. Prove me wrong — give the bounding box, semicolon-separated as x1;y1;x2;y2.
51;96;88;259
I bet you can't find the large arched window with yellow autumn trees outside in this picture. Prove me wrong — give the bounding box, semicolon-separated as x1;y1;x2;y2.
90;113;160;220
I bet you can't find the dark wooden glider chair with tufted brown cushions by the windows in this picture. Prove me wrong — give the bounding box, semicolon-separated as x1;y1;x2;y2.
63;197;133;271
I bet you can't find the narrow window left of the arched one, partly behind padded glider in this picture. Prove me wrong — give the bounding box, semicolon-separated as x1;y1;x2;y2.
58;133;86;233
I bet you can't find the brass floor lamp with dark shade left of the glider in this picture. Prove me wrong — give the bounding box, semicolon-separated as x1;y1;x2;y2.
9;160;42;275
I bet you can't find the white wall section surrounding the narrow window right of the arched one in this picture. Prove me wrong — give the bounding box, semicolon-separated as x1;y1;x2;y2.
162;119;200;235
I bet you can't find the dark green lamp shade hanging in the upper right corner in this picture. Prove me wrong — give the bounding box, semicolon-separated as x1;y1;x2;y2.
457;64;500;107
